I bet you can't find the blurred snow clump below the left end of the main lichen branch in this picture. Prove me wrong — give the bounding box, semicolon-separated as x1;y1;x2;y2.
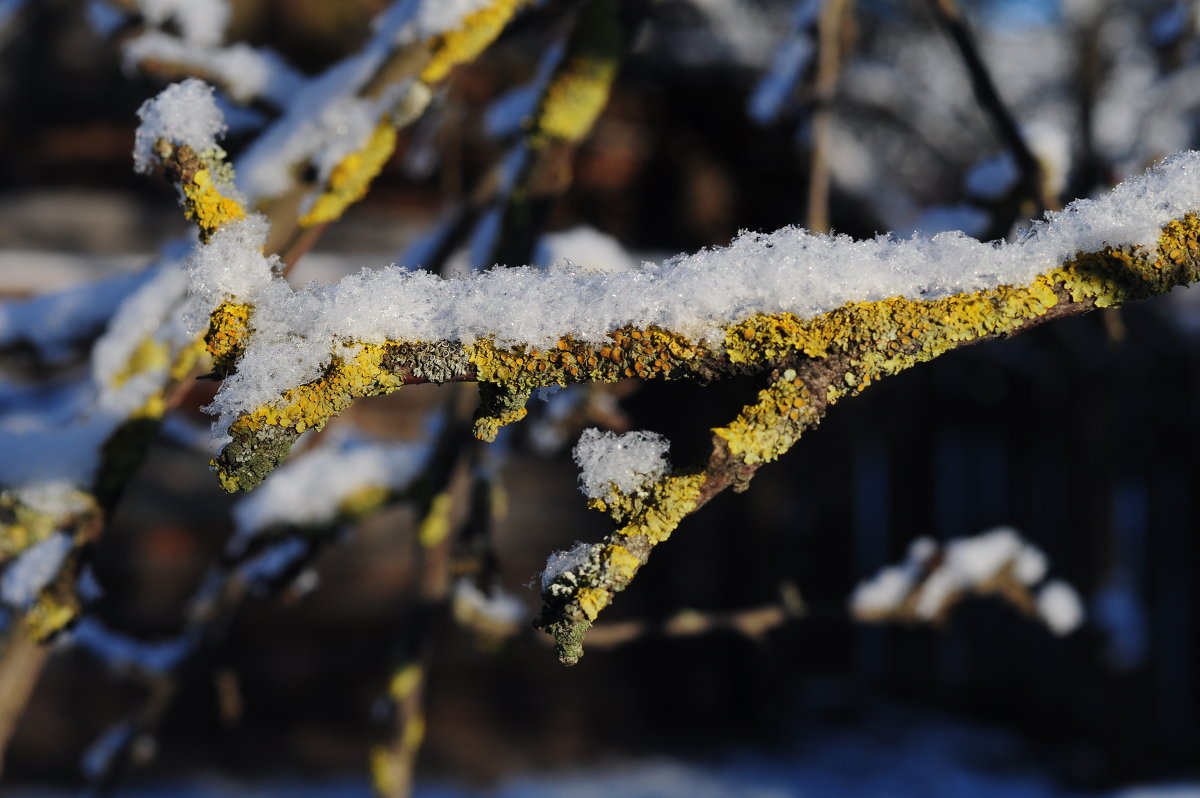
229;425;430;554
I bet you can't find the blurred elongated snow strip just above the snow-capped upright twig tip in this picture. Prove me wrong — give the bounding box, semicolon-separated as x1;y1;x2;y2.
121;30;304;107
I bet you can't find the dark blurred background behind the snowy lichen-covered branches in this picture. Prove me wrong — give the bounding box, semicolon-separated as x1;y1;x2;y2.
0;0;1200;796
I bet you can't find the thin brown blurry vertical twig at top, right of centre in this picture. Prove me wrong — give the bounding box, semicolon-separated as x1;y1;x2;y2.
805;0;853;233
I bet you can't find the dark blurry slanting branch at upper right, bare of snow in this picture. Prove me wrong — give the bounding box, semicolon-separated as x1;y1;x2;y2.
929;0;1062;216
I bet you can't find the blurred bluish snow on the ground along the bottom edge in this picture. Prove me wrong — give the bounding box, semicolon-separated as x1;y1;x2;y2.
25;706;1200;798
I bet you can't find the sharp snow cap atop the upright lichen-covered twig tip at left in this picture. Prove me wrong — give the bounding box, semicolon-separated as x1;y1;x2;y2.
133;79;226;173
